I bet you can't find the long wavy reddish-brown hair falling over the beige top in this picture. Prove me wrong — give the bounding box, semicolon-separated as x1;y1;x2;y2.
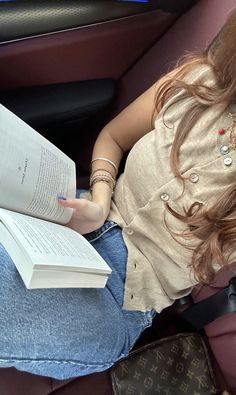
156;8;236;282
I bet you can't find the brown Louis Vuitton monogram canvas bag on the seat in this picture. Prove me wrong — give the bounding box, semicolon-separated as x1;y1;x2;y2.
112;333;218;395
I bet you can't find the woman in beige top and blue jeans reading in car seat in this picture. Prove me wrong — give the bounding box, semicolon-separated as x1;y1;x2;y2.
0;11;236;379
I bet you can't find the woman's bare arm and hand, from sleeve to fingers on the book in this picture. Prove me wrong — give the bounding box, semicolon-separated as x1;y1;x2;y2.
60;84;159;234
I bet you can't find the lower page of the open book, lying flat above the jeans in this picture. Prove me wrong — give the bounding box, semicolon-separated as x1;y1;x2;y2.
0;209;111;274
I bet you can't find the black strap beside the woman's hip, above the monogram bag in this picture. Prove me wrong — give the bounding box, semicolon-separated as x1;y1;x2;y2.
181;277;236;329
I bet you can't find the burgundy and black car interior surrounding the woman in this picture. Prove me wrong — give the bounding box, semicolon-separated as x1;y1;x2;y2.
0;0;236;395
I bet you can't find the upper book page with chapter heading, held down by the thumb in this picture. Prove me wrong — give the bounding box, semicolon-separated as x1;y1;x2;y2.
0;105;76;223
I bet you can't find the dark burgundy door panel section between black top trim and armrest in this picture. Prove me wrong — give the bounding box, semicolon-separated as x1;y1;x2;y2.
0;10;176;89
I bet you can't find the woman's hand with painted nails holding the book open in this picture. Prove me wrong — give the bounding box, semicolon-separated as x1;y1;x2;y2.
58;199;106;234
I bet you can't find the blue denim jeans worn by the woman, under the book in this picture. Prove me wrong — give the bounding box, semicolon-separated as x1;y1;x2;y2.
0;222;153;379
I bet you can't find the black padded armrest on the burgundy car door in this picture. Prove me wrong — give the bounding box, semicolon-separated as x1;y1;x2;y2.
0;78;115;128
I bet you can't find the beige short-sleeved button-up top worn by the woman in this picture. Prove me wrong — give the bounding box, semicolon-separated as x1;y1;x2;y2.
109;66;236;312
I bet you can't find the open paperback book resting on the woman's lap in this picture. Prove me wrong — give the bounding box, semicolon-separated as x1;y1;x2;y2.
0;105;111;288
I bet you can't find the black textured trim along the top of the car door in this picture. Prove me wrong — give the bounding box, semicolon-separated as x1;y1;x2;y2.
0;0;196;42
